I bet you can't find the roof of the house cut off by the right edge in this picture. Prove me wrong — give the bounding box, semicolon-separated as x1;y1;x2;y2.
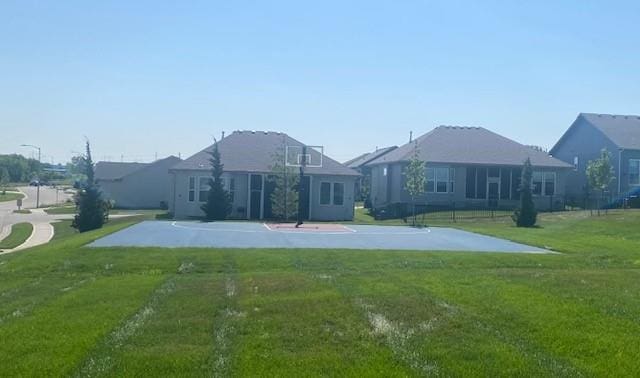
551;113;640;152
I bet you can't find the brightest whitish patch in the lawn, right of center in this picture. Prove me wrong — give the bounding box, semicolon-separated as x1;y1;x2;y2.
356;299;438;375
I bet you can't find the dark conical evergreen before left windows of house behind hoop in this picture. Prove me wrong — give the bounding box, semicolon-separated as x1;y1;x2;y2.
201;141;231;221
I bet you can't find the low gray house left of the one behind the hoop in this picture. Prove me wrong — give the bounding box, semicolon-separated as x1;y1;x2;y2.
95;156;182;209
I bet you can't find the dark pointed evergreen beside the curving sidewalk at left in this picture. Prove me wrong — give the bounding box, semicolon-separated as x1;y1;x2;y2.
71;141;109;232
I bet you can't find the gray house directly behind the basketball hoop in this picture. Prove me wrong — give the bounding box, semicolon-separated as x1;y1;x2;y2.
169;131;360;221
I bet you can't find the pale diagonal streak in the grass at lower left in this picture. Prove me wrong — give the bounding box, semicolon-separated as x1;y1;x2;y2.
75;280;176;377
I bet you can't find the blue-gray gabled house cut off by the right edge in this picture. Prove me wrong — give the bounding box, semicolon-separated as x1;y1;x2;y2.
551;113;640;200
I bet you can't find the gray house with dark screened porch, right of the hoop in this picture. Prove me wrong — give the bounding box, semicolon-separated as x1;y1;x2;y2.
368;126;572;210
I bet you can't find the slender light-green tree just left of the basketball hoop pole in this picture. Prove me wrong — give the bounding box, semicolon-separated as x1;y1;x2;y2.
269;144;300;221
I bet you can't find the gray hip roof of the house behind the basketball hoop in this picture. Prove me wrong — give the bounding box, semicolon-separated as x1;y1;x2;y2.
172;131;360;176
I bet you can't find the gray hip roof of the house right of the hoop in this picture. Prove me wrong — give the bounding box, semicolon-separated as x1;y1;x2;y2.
369;126;571;168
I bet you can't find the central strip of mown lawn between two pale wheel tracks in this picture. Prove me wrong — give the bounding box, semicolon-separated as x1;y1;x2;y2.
232;272;412;376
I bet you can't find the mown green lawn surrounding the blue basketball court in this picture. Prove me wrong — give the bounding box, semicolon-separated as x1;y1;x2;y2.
0;211;640;376
